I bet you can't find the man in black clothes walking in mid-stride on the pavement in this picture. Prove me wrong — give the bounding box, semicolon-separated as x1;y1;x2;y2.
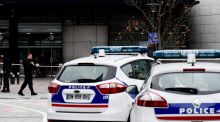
18;53;37;96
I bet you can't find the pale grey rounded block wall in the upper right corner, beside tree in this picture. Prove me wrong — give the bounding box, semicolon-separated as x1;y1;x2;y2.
190;0;220;49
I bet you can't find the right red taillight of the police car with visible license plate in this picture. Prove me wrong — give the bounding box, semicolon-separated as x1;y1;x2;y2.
97;83;127;94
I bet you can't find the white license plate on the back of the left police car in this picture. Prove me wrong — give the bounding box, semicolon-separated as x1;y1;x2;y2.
66;94;90;100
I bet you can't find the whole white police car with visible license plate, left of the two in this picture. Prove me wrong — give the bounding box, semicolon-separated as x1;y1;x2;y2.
48;46;154;121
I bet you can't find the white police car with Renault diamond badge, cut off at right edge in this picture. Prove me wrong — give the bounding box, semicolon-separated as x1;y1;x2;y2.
131;50;220;122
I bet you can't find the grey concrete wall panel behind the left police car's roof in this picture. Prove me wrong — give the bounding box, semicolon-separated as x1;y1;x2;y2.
63;21;108;62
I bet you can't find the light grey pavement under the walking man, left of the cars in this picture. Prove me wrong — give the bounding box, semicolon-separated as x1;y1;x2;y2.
0;78;53;122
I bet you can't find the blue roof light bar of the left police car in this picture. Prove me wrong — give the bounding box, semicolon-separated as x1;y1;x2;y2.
91;46;148;54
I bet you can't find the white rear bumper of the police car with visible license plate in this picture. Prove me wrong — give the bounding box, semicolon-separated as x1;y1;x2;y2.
47;94;132;122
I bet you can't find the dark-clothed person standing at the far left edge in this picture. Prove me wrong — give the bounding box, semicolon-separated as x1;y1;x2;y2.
1;56;12;92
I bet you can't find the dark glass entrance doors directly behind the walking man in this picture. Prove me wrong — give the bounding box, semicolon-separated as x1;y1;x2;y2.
20;48;62;77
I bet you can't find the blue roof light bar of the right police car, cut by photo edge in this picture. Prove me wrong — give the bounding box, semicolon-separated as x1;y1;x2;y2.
153;49;220;59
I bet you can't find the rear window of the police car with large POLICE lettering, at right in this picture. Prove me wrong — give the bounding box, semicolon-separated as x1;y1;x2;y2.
151;72;220;95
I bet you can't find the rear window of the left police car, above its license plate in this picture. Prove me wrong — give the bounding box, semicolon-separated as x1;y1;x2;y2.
58;65;116;83
